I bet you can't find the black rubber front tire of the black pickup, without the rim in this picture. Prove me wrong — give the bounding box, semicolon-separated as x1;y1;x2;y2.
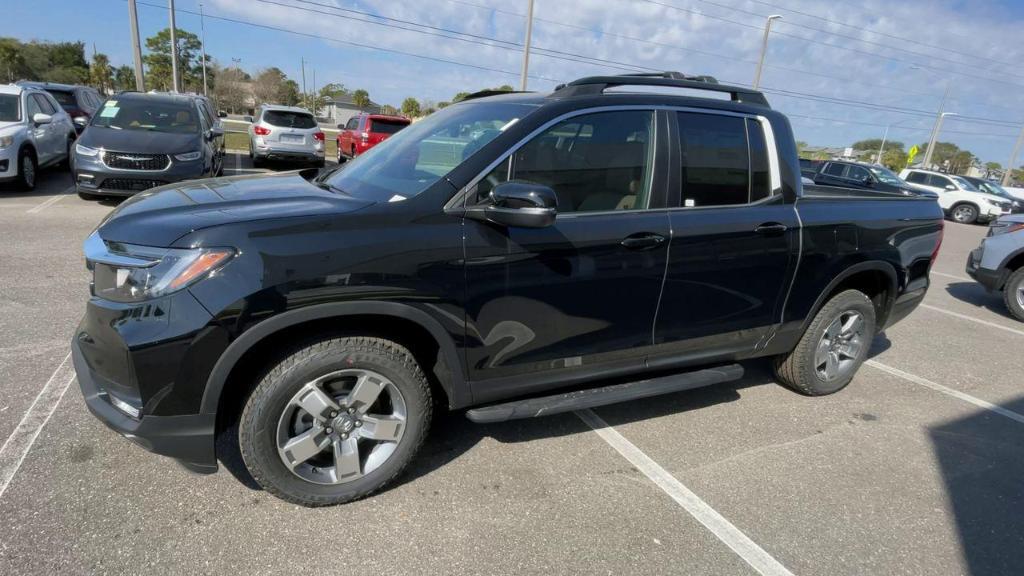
239;337;432;506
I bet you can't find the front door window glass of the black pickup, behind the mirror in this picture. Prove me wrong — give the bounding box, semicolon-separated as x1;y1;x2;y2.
476;111;654;213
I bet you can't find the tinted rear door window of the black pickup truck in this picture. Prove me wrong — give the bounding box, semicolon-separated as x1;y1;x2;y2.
678;112;771;207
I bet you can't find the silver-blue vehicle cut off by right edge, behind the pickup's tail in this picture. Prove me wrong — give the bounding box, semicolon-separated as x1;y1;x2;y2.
967;214;1024;322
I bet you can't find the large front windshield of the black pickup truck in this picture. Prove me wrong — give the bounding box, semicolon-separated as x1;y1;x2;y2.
327;101;538;202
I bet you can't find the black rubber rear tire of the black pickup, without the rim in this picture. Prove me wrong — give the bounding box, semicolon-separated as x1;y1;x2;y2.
774;290;874;396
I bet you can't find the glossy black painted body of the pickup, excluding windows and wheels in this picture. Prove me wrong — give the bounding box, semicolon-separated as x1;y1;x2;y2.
73;90;942;470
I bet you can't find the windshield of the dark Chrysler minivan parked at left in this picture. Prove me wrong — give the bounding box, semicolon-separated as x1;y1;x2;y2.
92;96;200;134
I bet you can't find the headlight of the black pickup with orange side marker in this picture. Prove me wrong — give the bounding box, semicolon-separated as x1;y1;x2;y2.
86;238;236;302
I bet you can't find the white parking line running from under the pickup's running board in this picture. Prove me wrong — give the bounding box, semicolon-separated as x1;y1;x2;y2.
575;409;793;576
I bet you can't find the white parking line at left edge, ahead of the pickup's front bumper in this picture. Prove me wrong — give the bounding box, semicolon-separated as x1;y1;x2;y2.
0;353;75;498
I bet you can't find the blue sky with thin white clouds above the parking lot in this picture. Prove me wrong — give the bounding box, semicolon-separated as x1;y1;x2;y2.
0;0;1024;164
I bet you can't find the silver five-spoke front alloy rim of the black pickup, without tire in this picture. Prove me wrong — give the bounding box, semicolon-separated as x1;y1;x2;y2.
276;369;408;485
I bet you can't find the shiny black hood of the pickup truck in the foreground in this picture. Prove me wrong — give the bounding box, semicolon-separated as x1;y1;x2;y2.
97;168;373;247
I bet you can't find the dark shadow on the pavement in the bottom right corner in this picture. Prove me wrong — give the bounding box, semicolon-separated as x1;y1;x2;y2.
929;396;1024;576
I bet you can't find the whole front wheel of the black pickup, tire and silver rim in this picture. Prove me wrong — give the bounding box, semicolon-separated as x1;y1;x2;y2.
239;337;431;506
